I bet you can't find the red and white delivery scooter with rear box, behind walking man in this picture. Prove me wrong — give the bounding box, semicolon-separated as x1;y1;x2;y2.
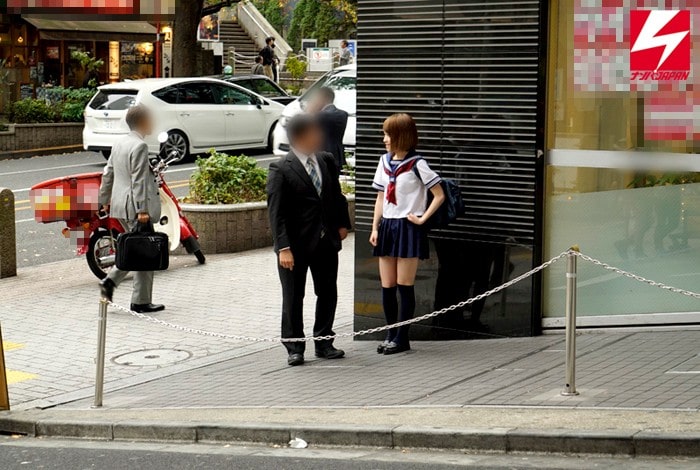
30;134;206;279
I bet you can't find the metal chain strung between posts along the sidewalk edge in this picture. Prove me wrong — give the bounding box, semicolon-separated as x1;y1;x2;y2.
109;250;700;343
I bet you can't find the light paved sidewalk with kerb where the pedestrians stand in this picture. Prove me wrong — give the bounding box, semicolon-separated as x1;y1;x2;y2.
0;233;700;456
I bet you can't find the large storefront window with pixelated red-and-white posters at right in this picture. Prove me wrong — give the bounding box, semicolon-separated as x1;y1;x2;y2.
543;0;700;326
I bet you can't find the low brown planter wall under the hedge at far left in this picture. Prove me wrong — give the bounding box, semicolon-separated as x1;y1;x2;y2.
0;122;85;159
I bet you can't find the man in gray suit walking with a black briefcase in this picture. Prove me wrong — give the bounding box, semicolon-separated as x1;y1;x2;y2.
100;106;165;313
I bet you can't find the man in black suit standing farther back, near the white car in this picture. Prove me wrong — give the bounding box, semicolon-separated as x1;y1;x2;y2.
309;87;348;169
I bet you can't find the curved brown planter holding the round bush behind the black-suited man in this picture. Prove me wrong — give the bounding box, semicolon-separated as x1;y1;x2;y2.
182;195;355;255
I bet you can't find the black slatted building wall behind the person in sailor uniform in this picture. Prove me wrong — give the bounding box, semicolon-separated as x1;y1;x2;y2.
355;0;544;339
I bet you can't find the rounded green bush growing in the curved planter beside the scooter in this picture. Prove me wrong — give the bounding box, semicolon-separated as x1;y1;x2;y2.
187;149;267;204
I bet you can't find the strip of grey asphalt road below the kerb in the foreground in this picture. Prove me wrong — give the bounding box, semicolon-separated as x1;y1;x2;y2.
0;438;700;470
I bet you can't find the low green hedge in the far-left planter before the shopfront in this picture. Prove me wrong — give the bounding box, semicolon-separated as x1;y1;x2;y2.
10;87;95;124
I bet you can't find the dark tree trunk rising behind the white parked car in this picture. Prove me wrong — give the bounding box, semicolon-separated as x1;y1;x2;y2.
173;0;204;77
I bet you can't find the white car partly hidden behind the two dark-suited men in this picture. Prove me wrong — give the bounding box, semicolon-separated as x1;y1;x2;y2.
274;64;357;166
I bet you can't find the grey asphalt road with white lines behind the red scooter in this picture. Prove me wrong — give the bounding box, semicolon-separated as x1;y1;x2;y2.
0;150;275;269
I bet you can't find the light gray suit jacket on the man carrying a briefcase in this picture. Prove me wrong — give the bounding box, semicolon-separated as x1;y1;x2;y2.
100;132;160;223
